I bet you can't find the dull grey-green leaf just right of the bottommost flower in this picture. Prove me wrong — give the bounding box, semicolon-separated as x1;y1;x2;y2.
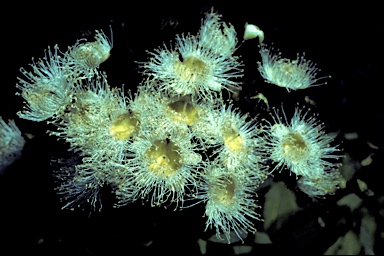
263;181;300;230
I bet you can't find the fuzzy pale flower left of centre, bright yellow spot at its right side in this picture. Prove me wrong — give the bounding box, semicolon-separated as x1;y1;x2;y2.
50;77;139;159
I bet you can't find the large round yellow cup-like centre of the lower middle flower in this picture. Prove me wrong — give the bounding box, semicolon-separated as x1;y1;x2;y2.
146;140;181;178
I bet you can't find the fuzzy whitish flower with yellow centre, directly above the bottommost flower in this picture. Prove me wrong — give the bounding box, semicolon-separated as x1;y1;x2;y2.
192;105;266;180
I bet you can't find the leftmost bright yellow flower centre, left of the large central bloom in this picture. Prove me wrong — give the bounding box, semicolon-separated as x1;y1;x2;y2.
109;113;139;140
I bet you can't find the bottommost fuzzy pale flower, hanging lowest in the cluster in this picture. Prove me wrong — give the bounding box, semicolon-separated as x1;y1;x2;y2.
196;162;261;243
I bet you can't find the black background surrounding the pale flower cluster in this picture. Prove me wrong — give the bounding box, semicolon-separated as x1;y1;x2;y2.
0;1;384;255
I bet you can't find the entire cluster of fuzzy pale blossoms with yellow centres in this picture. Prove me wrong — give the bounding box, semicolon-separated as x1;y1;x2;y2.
11;8;338;242
